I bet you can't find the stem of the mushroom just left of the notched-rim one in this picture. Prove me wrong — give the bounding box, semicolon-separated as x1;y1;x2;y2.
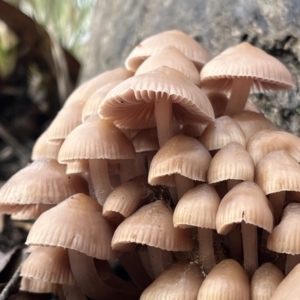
198;228;216;274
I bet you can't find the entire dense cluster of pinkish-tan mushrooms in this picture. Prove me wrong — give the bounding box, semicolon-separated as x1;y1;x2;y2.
0;30;300;300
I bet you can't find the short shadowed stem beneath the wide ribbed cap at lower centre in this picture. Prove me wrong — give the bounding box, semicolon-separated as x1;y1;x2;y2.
147;246;173;278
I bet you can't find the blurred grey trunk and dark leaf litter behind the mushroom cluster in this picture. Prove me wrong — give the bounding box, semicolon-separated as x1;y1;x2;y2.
0;0;300;182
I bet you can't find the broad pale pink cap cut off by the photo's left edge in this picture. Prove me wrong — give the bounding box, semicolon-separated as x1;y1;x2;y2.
0;158;87;205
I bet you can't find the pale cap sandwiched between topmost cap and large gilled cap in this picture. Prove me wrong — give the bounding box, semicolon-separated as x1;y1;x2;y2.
135;46;200;85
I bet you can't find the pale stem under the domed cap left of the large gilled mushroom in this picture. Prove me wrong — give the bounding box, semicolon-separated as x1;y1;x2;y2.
89;159;111;206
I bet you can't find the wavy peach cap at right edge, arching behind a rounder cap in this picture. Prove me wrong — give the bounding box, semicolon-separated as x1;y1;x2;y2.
247;129;300;164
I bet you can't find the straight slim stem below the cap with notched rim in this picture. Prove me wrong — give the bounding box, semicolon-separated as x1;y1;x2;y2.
241;221;258;277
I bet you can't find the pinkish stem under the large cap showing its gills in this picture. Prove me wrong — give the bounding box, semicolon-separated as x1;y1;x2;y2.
155;95;173;148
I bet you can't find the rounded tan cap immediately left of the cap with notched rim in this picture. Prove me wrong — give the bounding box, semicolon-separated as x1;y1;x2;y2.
173;183;221;229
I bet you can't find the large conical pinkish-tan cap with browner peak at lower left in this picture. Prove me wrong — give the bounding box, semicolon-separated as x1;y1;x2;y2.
26;194;117;259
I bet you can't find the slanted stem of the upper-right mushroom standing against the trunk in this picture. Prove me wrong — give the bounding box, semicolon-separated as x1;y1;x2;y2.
224;77;253;116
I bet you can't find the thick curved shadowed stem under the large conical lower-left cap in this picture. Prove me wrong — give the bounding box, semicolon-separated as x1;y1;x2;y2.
68;249;140;300
